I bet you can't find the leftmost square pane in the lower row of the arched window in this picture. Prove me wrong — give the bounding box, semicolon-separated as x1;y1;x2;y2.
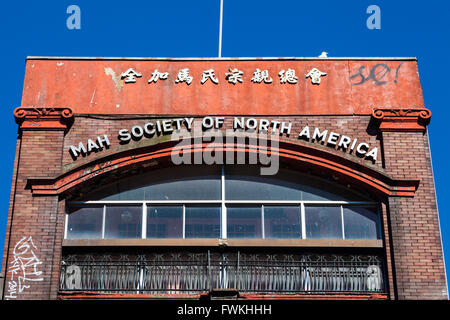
67;206;103;239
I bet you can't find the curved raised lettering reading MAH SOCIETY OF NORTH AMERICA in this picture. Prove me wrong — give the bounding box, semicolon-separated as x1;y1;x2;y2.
69;116;378;162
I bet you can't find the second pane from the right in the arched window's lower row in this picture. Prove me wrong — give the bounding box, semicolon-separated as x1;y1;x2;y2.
305;206;342;239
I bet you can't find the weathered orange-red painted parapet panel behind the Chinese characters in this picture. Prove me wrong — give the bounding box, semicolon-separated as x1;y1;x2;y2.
21;58;424;115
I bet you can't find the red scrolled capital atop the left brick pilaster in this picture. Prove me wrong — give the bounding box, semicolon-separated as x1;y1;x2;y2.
14;107;73;130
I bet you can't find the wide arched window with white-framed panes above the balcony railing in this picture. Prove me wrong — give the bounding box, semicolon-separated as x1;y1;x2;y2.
65;165;380;239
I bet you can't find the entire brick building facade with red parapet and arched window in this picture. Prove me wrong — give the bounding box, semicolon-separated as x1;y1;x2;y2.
2;57;448;300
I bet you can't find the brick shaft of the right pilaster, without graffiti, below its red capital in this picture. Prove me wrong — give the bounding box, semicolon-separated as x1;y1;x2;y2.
383;132;448;299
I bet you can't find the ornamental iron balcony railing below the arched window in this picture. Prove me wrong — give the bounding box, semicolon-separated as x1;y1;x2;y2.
60;251;386;294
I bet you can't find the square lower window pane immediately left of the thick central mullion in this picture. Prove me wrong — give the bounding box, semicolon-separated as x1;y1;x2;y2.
185;206;220;238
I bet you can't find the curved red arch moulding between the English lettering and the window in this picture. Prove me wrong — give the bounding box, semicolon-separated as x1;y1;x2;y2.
27;141;419;198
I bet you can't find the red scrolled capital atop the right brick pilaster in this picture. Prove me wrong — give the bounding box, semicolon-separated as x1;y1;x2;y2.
372;108;431;132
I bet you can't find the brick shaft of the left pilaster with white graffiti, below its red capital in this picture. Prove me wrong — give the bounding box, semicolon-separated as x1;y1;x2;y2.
3;130;64;299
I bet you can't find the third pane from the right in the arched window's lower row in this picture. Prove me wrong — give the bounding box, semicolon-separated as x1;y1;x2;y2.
264;206;302;239
